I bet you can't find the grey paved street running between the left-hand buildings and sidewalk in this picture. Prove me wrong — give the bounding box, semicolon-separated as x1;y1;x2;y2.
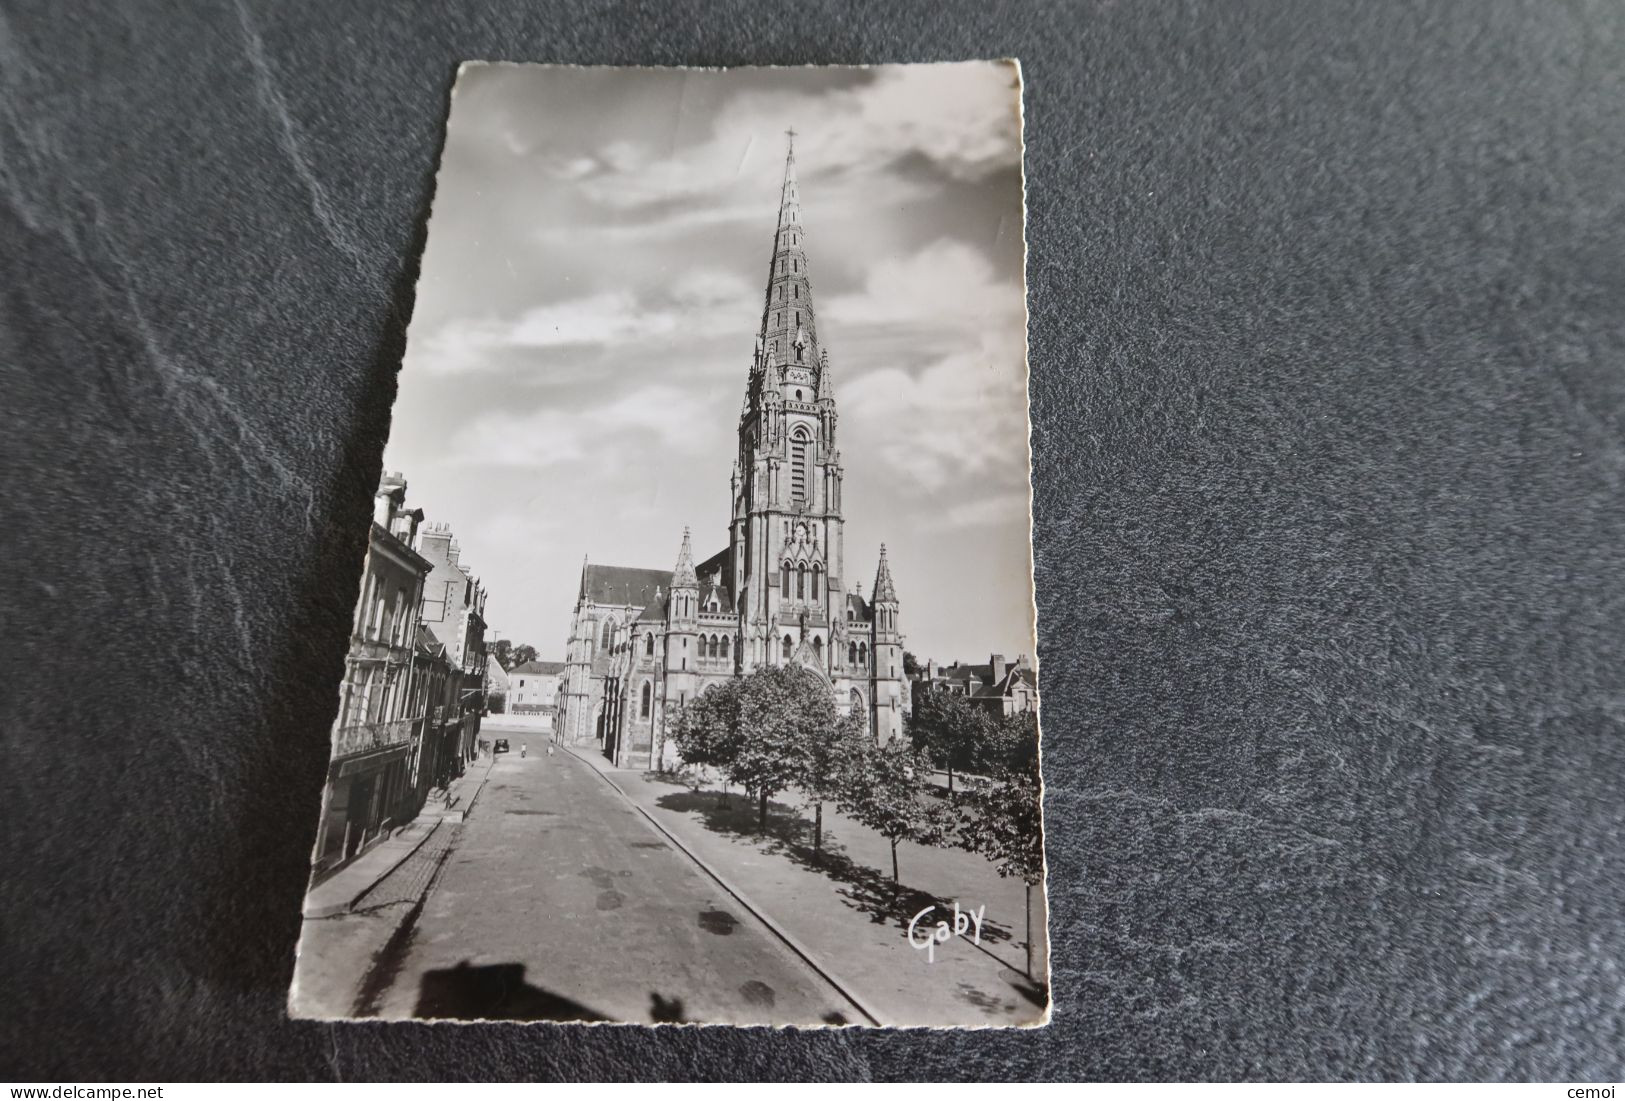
372;729;861;1025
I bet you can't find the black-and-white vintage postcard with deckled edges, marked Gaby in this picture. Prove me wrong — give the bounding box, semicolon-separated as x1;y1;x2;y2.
289;62;1050;1028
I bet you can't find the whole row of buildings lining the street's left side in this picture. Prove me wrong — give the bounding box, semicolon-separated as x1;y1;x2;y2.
312;473;488;875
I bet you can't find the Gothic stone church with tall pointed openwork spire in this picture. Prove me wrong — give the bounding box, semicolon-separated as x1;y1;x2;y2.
557;138;910;768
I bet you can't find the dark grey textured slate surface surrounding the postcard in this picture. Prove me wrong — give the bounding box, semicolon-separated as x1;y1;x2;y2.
0;0;1625;1080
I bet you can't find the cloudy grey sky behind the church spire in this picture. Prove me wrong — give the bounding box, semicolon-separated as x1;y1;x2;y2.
385;63;1034;661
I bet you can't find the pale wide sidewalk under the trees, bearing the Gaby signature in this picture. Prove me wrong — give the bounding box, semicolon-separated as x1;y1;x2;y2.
570;747;1043;1026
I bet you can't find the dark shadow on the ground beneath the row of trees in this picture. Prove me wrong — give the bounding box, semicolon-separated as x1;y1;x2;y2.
657;791;1012;963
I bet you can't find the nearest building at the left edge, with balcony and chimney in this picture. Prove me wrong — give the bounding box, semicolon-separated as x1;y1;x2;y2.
314;474;431;872
